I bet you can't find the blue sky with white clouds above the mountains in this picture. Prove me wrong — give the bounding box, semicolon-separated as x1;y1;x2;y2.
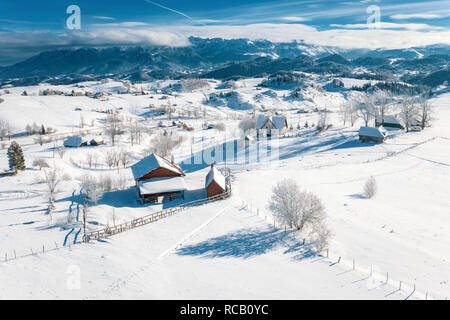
0;0;450;65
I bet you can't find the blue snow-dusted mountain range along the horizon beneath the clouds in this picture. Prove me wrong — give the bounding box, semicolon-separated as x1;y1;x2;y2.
0;37;450;86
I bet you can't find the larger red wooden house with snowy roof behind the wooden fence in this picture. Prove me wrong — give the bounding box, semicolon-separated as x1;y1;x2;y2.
131;153;187;202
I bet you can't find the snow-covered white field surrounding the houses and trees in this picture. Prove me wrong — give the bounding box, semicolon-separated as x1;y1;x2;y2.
0;79;450;299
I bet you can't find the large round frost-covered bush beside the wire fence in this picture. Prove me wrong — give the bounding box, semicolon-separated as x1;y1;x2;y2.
269;179;331;251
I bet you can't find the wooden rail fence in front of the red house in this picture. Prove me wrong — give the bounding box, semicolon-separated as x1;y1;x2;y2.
83;185;231;242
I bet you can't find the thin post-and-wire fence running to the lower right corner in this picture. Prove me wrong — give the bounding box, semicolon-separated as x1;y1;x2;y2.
241;201;448;300
